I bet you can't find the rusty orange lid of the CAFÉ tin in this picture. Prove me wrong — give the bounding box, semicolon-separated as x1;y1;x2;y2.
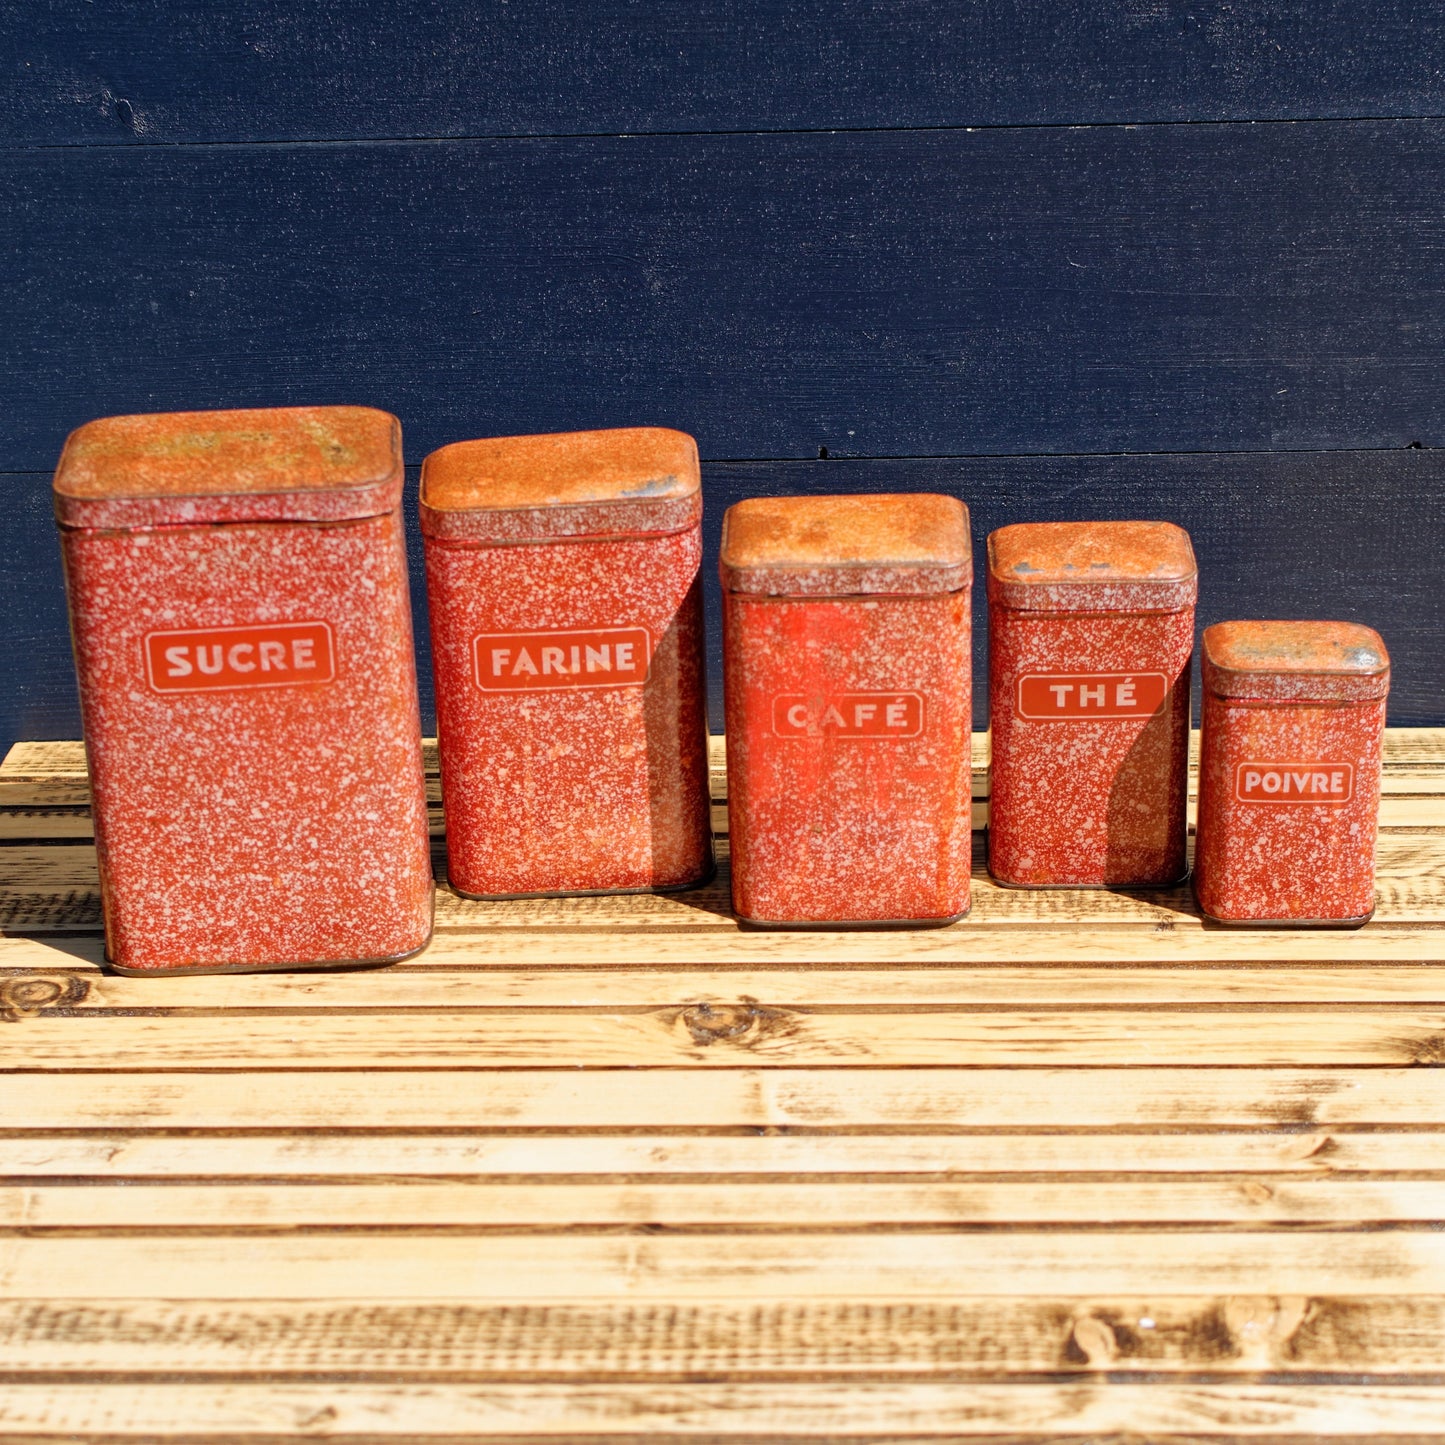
718;491;972;597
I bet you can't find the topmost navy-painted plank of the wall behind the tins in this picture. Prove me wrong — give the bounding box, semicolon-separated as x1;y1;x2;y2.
11;0;1445;145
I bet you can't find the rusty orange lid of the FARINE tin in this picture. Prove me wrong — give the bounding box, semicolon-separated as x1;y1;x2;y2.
422;426;702;545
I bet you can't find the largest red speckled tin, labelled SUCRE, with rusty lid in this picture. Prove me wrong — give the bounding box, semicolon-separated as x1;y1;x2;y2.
55;406;432;972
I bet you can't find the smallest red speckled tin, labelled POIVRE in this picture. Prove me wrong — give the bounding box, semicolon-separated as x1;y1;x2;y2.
1194;621;1390;928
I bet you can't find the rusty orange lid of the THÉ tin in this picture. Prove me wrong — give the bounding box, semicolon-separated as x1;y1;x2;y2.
988;522;1199;613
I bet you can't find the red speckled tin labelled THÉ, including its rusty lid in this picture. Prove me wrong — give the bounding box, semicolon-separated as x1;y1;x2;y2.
988;522;1196;887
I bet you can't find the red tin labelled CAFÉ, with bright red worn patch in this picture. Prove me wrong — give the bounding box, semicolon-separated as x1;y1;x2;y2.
720;493;972;928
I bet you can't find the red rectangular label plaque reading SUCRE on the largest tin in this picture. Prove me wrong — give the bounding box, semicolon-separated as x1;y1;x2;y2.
146;623;337;692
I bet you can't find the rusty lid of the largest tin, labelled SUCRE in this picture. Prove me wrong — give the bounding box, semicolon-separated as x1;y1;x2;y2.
55;406;402;527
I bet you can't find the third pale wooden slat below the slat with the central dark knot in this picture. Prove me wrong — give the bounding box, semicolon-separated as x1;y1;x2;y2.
0;1176;1445;1237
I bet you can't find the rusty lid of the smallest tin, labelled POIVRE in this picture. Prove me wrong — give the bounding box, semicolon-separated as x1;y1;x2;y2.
1204;621;1390;702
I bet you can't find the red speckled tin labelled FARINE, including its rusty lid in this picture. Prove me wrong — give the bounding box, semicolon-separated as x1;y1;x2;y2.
422;426;712;897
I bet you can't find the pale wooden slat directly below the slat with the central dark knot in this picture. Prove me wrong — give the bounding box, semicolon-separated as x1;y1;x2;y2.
0;1066;1445;1131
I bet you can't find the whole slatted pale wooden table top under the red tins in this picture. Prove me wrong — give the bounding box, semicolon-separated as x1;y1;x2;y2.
0;731;1445;1442
